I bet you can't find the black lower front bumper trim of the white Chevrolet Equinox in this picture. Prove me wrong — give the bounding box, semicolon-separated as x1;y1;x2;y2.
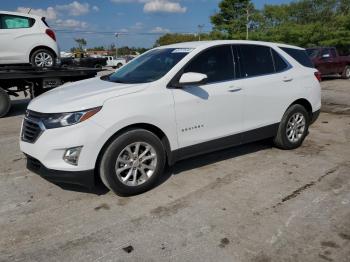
26;155;96;188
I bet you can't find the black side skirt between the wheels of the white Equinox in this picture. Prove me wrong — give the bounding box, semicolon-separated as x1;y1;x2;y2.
168;123;279;165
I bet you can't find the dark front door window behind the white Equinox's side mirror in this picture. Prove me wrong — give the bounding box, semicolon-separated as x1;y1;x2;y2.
184;46;235;83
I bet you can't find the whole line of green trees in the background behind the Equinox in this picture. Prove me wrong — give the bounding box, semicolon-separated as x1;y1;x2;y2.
156;0;350;53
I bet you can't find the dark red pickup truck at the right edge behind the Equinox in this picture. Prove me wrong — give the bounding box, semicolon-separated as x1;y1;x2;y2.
306;47;350;79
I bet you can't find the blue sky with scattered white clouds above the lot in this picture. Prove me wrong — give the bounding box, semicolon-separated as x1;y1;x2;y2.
0;0;290;51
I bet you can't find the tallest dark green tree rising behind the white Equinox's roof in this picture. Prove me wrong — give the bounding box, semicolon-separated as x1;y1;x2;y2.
210;0;258;39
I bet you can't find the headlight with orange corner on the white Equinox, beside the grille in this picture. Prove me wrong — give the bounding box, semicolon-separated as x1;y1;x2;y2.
42;107;102;129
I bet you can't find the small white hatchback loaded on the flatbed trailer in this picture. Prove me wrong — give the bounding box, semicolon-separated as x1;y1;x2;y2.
0;11;59;67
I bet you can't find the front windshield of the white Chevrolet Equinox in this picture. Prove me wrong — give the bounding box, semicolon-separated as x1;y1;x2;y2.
101;48;191;84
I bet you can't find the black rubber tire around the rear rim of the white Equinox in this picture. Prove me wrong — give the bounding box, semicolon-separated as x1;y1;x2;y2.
274;104;310;150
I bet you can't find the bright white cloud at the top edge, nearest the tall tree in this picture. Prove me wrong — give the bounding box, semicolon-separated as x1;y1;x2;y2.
111;0;187;13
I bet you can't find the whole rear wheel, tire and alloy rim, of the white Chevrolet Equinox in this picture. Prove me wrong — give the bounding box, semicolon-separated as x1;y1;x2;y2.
274;104;310;149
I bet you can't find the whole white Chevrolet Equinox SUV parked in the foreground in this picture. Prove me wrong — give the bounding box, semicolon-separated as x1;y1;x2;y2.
20;41;321;195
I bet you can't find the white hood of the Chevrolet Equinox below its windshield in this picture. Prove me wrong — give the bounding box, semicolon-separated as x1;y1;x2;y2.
28;77;147;113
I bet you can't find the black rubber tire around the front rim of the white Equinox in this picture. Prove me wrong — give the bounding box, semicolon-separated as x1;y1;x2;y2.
98;129;166;196
